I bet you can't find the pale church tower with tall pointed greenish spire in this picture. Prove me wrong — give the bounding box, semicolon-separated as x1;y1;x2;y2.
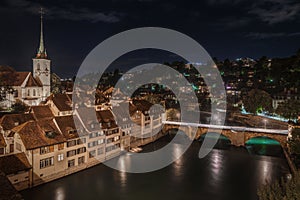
32;8;51;100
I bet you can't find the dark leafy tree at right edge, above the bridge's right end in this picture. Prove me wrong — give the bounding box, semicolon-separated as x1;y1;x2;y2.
276;99;300;119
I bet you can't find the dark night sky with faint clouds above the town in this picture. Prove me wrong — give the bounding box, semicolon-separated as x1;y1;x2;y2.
0;0;300;77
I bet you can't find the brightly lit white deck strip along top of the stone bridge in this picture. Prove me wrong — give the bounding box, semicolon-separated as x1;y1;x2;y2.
162;121;288;135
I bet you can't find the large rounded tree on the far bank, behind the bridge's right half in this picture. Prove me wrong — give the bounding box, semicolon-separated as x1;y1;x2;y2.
243;89;272;114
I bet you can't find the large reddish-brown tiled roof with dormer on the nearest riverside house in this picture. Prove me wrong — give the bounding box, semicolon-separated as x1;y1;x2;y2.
12;120;66;150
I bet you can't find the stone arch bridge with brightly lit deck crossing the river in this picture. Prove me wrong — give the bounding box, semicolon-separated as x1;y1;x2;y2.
162;121;288;146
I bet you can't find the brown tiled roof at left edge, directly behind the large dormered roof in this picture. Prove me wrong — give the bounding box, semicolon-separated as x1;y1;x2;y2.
0;113;34;130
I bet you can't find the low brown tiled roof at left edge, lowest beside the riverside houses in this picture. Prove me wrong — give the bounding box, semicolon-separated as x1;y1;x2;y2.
0;153;31;175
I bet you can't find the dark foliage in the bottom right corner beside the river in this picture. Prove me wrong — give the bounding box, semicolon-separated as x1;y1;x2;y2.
257;172;300;200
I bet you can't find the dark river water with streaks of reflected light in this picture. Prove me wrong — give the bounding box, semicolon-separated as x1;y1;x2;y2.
21;136;289;200
